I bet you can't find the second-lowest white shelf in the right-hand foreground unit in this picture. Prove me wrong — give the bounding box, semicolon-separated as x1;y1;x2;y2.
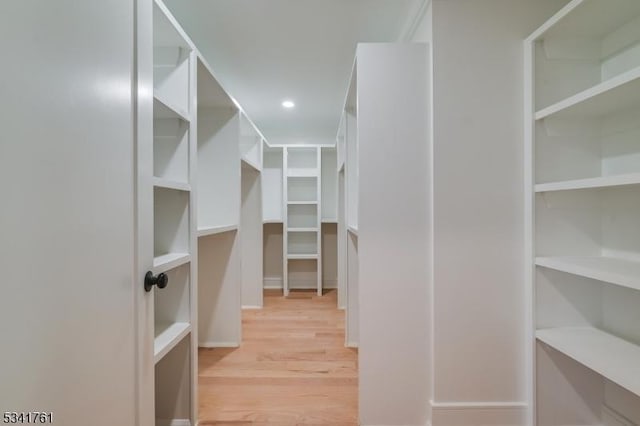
535;257;640;290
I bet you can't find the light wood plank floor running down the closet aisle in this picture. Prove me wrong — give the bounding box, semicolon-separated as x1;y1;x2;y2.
198;290;358;426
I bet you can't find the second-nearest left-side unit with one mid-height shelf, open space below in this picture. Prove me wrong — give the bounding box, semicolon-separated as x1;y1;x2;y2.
197;55;242;347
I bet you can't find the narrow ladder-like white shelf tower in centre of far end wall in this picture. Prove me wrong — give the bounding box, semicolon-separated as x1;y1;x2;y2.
282;145;322;296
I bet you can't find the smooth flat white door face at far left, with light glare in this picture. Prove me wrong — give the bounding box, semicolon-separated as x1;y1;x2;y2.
0;0;138;426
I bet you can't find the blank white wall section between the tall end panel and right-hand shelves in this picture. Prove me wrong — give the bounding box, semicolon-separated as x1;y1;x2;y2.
419;0;567;426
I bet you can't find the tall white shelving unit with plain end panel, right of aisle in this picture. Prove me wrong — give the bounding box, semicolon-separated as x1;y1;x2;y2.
337;43;431;424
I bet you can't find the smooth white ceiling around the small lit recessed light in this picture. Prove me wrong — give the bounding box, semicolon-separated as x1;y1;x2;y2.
165;0;424;143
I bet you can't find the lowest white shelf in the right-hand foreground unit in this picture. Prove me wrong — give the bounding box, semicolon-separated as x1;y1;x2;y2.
536;327;640;395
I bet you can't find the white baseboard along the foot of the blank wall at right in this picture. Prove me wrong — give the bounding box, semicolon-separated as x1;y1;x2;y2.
429;401;528;426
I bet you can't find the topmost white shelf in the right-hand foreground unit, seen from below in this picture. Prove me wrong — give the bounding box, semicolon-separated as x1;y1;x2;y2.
535;67;640;120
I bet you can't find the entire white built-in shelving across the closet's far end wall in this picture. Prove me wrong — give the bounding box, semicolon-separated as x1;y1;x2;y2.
262;144;342;300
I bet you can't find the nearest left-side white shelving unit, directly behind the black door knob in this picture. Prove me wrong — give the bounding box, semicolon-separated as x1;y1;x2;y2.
145;1;197;425
